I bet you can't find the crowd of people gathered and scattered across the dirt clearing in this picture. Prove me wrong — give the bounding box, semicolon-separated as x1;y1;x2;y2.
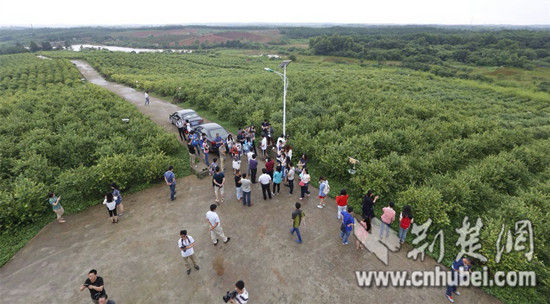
44;115;471;304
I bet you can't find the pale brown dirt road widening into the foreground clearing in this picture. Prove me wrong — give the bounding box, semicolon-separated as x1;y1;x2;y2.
0;62;498;304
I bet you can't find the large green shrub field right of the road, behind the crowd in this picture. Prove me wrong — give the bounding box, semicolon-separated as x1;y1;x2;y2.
44;51;550;303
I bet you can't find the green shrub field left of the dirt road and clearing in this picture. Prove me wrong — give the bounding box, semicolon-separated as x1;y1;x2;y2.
0;54;190;265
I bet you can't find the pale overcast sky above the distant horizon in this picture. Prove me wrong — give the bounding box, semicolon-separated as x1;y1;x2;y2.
0;0;550;26
